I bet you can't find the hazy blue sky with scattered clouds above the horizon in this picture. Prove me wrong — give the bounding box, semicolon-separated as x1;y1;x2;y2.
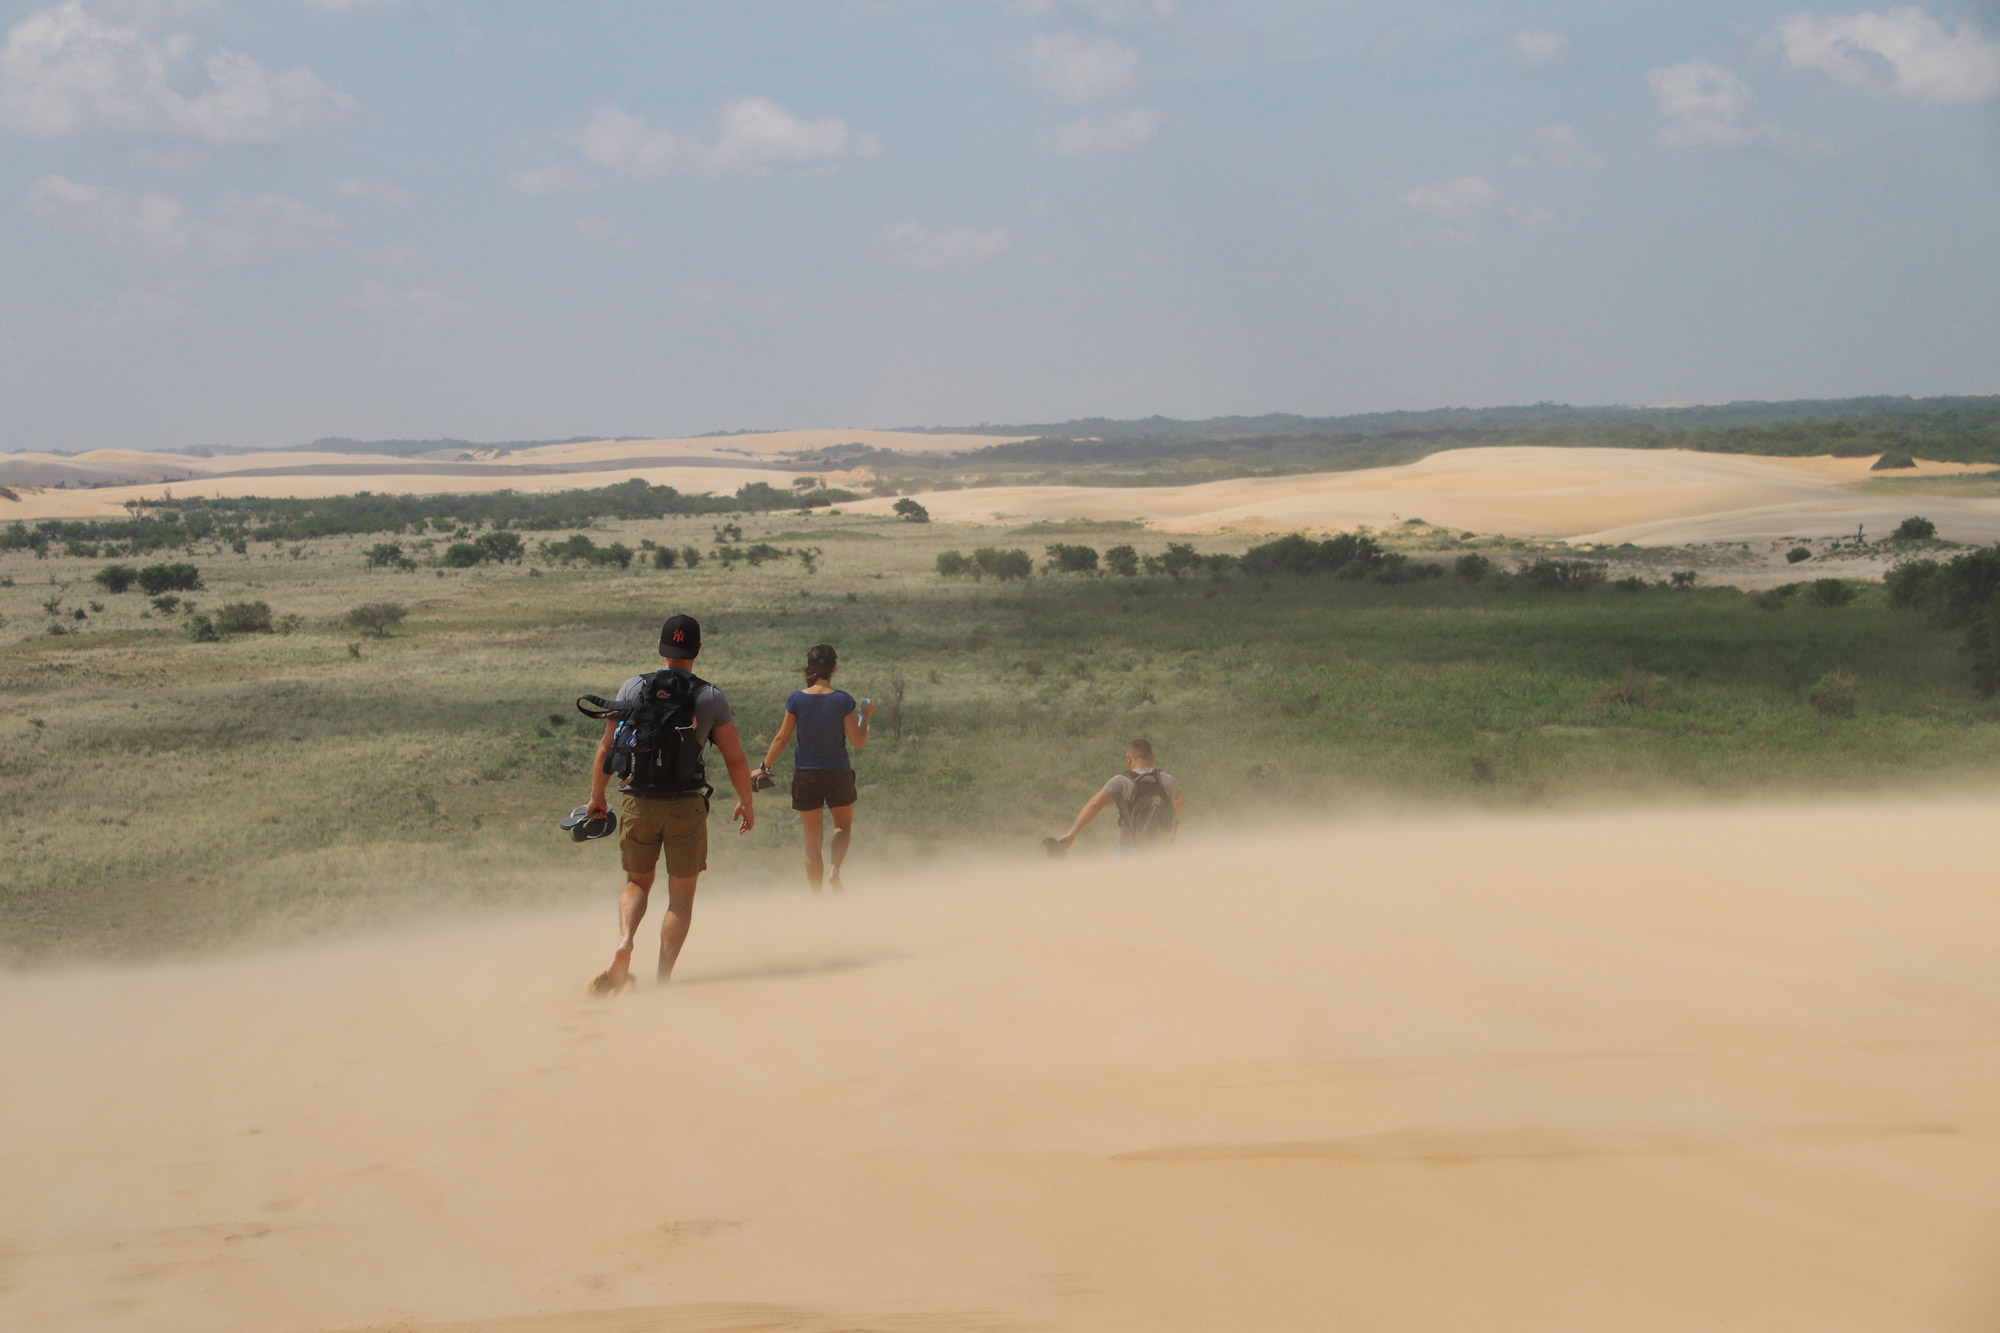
0;0;2000;450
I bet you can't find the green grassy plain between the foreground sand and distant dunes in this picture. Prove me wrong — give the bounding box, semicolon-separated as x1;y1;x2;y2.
0;516;2000;959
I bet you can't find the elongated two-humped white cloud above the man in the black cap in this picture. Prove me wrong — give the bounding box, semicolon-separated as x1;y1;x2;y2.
508;98;882;194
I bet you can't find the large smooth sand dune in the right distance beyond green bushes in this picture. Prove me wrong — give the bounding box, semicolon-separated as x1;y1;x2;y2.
854;448;2000;544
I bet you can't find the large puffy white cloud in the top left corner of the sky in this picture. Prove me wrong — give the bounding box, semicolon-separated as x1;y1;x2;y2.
0;0;354;144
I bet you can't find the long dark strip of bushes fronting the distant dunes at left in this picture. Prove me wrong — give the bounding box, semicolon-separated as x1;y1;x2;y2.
0;478;860;556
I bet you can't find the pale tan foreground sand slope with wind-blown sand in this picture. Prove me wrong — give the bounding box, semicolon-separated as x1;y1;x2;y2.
0;801;2000;1333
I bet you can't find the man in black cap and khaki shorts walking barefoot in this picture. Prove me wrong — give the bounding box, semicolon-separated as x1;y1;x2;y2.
590;616;756;995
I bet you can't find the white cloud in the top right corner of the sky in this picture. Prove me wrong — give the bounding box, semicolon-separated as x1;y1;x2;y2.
1778;8;2000;102
